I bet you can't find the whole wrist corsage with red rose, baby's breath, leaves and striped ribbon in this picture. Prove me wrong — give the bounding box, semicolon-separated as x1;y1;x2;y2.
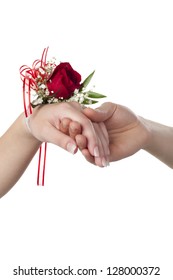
20;48;106;186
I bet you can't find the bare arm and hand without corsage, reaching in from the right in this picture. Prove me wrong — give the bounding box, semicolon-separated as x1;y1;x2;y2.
64;102;173;168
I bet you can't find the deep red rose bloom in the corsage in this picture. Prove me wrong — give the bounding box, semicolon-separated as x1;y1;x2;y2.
47;62;81;99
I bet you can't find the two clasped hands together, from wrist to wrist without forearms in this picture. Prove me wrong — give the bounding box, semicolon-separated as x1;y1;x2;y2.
29;102;148;167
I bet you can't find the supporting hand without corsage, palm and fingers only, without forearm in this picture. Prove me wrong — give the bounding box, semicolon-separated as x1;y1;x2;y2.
79;102;149;163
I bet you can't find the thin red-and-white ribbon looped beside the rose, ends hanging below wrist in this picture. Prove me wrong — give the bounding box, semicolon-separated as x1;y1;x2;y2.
20;48;48;186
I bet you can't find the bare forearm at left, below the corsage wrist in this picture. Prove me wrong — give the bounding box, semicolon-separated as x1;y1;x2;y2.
0;114;41;197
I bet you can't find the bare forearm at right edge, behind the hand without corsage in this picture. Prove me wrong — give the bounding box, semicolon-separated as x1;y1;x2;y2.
141;118;173;168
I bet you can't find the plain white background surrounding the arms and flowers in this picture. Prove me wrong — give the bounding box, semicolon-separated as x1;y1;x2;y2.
0;0;173;280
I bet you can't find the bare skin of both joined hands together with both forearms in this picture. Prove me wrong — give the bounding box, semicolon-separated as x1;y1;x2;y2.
0;100;173;197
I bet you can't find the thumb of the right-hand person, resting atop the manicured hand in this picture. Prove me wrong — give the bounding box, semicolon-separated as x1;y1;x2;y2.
83;102;117;122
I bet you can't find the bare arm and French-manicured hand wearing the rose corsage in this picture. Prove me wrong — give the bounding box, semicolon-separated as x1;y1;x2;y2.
0;102;109;197
